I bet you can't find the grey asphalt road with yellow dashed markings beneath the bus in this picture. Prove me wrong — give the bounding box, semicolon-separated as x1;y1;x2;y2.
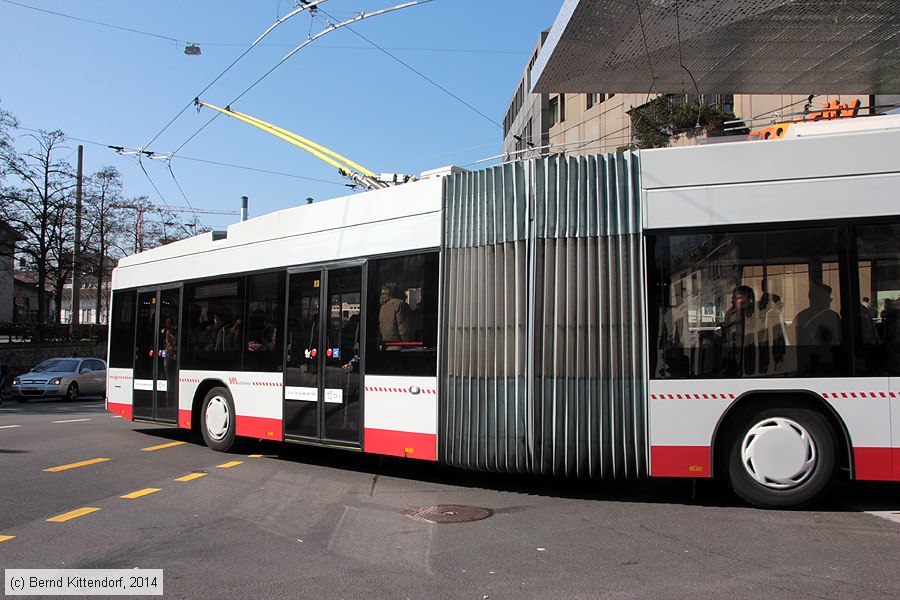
0;400;900;600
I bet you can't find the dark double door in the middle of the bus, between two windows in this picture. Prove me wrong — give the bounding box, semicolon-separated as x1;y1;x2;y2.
284;265;364;446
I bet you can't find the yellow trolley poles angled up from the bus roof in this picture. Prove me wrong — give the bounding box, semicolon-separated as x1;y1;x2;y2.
194;98;415;190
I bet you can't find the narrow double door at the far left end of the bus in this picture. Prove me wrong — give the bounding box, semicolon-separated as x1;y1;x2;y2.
132;288;181;423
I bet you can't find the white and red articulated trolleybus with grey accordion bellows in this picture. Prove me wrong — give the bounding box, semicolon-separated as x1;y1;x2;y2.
107;116;900;507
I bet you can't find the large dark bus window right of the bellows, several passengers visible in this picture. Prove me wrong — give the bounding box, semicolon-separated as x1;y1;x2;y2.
649;228;849;379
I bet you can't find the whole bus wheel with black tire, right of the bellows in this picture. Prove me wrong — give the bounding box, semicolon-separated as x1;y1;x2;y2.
727;408;839;508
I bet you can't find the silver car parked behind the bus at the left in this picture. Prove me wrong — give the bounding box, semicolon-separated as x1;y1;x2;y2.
9;358;106;402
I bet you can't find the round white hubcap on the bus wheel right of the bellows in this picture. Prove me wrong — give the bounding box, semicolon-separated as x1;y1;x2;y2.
741;417;818;490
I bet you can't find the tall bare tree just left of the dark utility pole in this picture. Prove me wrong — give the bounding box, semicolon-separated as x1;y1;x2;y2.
0;130;75;322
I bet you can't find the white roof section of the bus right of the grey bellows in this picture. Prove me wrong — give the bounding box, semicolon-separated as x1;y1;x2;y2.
640;116;900;229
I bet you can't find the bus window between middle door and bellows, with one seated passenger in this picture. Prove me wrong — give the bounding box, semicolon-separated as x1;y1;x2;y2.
366;252;439;376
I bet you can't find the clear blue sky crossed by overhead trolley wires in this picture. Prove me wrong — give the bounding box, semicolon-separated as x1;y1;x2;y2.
0;0;563;229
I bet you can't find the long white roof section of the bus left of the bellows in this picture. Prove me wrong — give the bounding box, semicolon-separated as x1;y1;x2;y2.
113;178;443;288
